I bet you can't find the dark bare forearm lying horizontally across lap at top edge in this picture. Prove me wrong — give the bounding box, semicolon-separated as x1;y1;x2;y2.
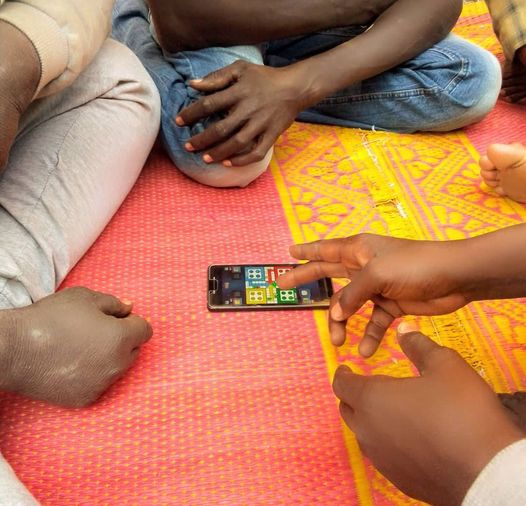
148;0;396;51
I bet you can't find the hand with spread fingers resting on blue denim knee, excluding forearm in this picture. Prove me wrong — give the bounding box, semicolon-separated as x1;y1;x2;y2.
176;60;312;167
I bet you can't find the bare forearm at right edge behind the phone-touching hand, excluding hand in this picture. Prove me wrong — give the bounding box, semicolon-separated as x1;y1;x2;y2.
451;224;526;300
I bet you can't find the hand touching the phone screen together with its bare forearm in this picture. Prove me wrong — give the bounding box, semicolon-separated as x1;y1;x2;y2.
278;225;526;357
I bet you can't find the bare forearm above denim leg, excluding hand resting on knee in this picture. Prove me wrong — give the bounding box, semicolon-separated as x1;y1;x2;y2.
290;0;462;105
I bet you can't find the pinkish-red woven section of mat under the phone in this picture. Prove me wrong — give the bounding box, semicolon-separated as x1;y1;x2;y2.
0;157;355;505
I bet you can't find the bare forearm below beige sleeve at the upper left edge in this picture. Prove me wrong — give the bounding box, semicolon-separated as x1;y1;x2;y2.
0;21;41;170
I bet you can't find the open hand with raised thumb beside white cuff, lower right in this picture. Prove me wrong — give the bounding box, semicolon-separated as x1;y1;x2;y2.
333;332;524;506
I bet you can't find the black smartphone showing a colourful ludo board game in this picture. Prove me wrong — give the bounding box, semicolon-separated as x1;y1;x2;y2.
208;264;333;311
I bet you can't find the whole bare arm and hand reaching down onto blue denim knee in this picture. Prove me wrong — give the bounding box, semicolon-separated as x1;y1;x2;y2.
172;0;462;166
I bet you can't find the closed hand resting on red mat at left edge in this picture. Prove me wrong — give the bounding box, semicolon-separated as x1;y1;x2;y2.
0;288;152;407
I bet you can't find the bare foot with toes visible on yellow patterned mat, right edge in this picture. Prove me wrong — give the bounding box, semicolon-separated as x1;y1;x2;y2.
480;142;526;202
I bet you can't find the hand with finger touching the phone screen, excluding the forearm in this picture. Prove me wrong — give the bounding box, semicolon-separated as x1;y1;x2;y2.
278;234;469;357
